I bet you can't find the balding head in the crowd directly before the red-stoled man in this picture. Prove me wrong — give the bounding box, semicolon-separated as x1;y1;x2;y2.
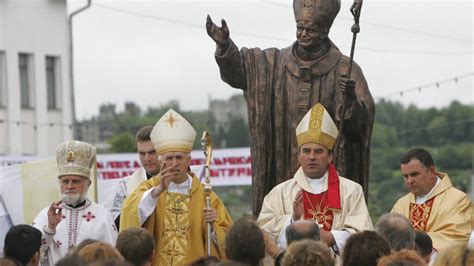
285;220;320;246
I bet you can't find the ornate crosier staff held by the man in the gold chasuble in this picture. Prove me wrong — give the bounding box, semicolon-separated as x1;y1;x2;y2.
201;131;212;257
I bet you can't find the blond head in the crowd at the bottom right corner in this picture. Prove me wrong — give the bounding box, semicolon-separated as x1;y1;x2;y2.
433;244;474;266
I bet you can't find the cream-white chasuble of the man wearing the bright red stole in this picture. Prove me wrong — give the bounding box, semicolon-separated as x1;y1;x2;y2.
258;167;373;249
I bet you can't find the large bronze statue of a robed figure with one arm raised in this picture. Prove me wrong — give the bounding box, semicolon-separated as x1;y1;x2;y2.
206;0;375;215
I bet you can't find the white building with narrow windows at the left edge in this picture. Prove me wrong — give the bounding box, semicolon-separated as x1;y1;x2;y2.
0;0;73;156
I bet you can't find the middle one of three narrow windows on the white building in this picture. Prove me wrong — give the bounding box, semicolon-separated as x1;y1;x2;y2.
18;54;33;108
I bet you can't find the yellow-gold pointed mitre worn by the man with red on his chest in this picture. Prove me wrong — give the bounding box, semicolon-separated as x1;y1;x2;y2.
296;103;338;150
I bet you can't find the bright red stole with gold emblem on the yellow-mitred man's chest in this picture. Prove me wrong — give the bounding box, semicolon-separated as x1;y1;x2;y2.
303;164;341;231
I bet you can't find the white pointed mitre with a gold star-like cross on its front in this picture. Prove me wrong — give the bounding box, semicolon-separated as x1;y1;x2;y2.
150;109;196;154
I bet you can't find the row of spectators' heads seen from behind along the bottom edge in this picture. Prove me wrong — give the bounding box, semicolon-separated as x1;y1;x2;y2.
0;213;474;266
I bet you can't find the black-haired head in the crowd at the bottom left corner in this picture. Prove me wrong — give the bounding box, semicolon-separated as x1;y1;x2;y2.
3;224;42;265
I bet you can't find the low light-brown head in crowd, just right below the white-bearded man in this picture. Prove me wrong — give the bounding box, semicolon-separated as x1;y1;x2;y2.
78;242;124;264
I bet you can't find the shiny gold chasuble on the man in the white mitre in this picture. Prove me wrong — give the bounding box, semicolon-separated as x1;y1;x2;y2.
120;173;232;265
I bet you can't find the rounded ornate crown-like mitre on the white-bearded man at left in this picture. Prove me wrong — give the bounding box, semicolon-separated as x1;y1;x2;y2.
56;140;96;179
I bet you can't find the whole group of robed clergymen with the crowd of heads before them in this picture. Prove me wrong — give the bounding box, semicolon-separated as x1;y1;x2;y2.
0;104;474;265
